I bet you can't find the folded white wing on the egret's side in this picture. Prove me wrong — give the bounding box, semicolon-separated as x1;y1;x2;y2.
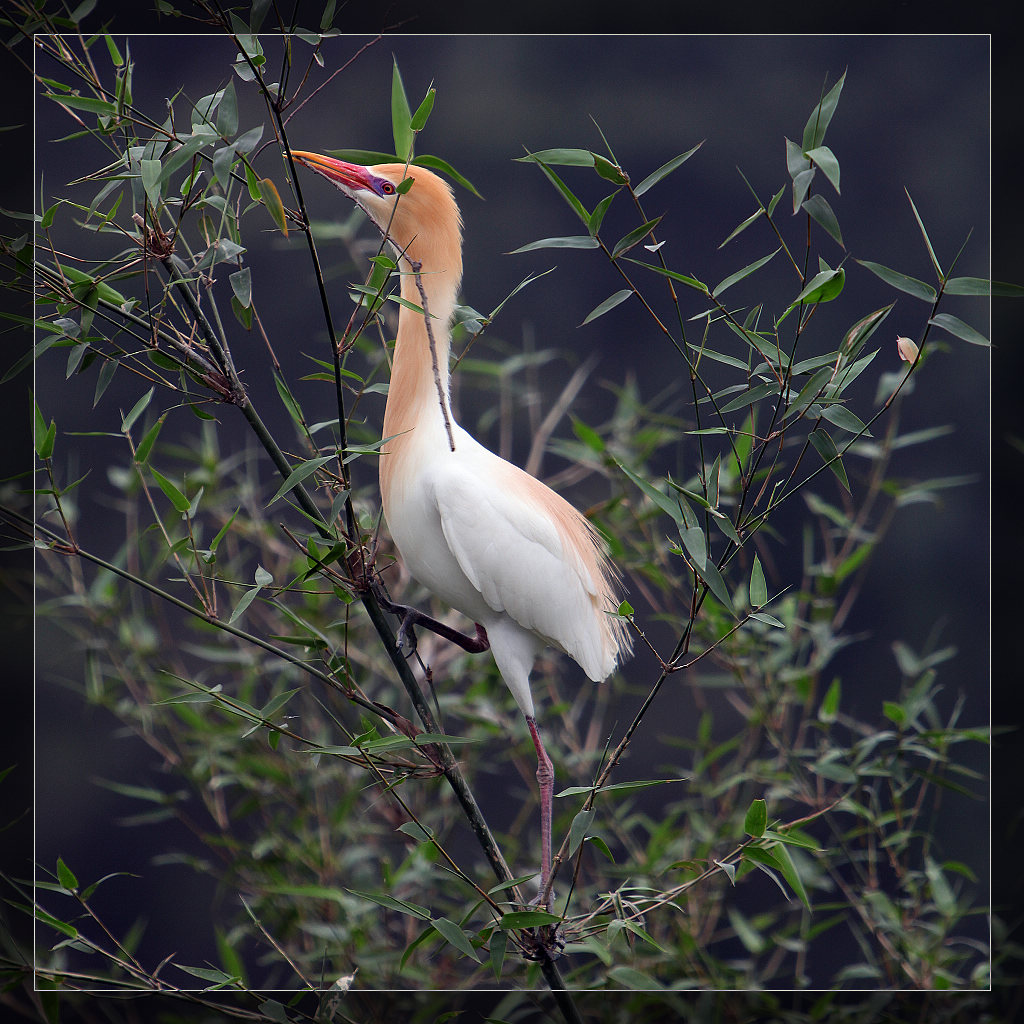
431;453;613;679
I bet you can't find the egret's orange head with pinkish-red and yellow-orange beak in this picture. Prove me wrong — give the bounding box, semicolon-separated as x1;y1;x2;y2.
292;152;462;284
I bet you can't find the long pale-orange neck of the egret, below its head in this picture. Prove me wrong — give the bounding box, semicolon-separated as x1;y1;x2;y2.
380;271;455;490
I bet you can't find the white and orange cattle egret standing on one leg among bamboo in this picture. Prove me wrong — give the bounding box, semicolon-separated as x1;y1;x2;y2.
293;153;632;905
